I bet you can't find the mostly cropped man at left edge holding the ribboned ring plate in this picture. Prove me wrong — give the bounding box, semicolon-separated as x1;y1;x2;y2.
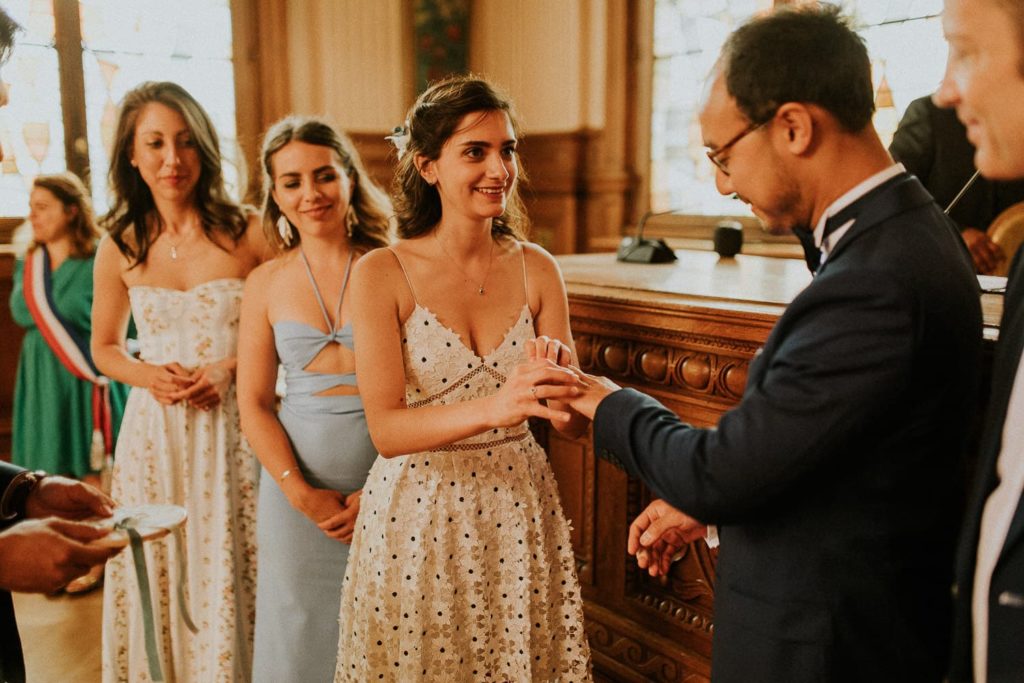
0;7;117;683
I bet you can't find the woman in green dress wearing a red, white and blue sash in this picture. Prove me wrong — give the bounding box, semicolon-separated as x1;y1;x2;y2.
10;173;128;484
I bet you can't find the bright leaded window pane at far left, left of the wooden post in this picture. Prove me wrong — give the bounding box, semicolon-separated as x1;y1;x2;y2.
0;0;66;216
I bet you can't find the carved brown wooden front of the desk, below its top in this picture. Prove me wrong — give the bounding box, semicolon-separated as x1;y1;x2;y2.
549;256;783;681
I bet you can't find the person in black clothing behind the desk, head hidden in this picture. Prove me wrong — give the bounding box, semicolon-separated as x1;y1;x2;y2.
889;97;1024;274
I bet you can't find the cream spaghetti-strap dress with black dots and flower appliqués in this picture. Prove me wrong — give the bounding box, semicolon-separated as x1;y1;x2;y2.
335;250;591;683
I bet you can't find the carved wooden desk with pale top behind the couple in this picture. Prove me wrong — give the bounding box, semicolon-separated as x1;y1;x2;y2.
547;251;1001;682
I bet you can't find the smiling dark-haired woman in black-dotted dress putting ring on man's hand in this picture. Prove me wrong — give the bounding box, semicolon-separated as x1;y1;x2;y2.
335;77;591;682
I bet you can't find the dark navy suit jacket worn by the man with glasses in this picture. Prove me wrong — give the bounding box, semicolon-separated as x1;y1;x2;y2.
594;174;981;683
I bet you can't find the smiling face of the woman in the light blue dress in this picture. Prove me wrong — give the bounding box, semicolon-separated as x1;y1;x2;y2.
270;140;352;237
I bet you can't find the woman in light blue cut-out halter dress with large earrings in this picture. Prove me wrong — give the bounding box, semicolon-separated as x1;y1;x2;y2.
239;117;391;683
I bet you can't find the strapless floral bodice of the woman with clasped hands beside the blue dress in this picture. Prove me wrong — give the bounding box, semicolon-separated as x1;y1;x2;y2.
128;278;245;369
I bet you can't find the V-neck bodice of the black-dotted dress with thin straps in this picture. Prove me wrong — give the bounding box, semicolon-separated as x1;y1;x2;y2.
401;304;537;451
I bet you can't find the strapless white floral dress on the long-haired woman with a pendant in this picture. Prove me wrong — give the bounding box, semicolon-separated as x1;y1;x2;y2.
102;279;259;683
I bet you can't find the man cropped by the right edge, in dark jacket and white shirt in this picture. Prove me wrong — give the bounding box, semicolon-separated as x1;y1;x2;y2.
935;0;1024;683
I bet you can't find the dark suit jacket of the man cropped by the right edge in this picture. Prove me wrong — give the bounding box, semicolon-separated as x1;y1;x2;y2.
950;241;1024;683
